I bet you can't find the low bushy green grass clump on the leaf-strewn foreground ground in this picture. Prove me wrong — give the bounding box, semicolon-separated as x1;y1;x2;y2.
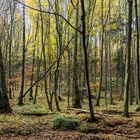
52;116;78;130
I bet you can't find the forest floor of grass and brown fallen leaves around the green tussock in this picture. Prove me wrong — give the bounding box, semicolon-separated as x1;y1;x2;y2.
0;98;140;140
